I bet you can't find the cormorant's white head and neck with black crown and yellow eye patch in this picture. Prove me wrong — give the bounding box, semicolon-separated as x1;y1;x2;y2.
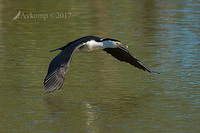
102;38;128;48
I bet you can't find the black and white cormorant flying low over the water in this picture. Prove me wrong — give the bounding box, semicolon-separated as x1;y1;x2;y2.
44;36;159;93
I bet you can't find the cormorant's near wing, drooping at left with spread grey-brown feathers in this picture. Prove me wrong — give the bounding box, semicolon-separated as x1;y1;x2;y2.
44;44;84;93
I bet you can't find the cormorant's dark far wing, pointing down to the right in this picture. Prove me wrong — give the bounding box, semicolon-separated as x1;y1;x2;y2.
103;46;159;74
